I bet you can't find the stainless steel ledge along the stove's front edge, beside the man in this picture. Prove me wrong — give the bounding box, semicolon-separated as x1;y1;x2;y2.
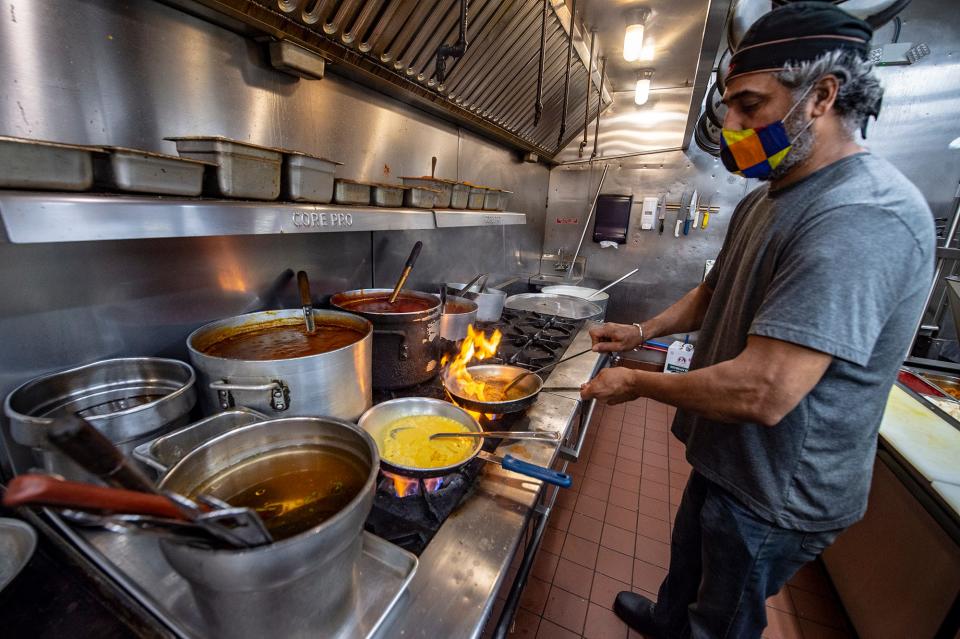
376;322;603;639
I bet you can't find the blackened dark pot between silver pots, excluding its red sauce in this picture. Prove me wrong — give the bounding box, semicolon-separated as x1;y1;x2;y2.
330;288;440;390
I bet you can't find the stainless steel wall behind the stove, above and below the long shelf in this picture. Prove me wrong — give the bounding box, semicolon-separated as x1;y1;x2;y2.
0;0;549;470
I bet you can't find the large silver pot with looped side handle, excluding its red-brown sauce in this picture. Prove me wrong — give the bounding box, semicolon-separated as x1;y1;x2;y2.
187;309;373;420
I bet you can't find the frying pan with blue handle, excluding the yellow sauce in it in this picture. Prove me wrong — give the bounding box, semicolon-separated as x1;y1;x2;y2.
359;398;573;488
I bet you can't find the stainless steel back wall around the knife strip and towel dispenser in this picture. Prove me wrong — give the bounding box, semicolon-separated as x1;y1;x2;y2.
543;145;747;322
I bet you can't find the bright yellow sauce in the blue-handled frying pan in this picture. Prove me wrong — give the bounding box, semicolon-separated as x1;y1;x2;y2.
379;415;477;468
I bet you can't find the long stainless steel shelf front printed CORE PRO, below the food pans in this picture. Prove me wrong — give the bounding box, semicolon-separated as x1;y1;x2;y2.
0;191;526;244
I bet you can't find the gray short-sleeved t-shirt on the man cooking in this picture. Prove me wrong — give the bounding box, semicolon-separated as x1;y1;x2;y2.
673;153;936;532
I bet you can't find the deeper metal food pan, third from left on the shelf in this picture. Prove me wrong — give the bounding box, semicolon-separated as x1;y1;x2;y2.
165;136;283;200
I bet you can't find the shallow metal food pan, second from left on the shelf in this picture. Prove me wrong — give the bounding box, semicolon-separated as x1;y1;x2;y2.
93;146;217;197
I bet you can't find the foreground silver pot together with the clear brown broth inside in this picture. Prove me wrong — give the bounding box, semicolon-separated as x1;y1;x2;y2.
159;417;380;638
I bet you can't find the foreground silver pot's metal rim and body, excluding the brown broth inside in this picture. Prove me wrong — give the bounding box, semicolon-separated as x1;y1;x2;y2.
158;417;380;639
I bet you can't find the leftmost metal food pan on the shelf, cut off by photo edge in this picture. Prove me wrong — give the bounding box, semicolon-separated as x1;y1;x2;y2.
0;136;103;191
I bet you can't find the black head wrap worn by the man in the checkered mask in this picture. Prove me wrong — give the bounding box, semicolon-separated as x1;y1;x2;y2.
727;1;873;82
